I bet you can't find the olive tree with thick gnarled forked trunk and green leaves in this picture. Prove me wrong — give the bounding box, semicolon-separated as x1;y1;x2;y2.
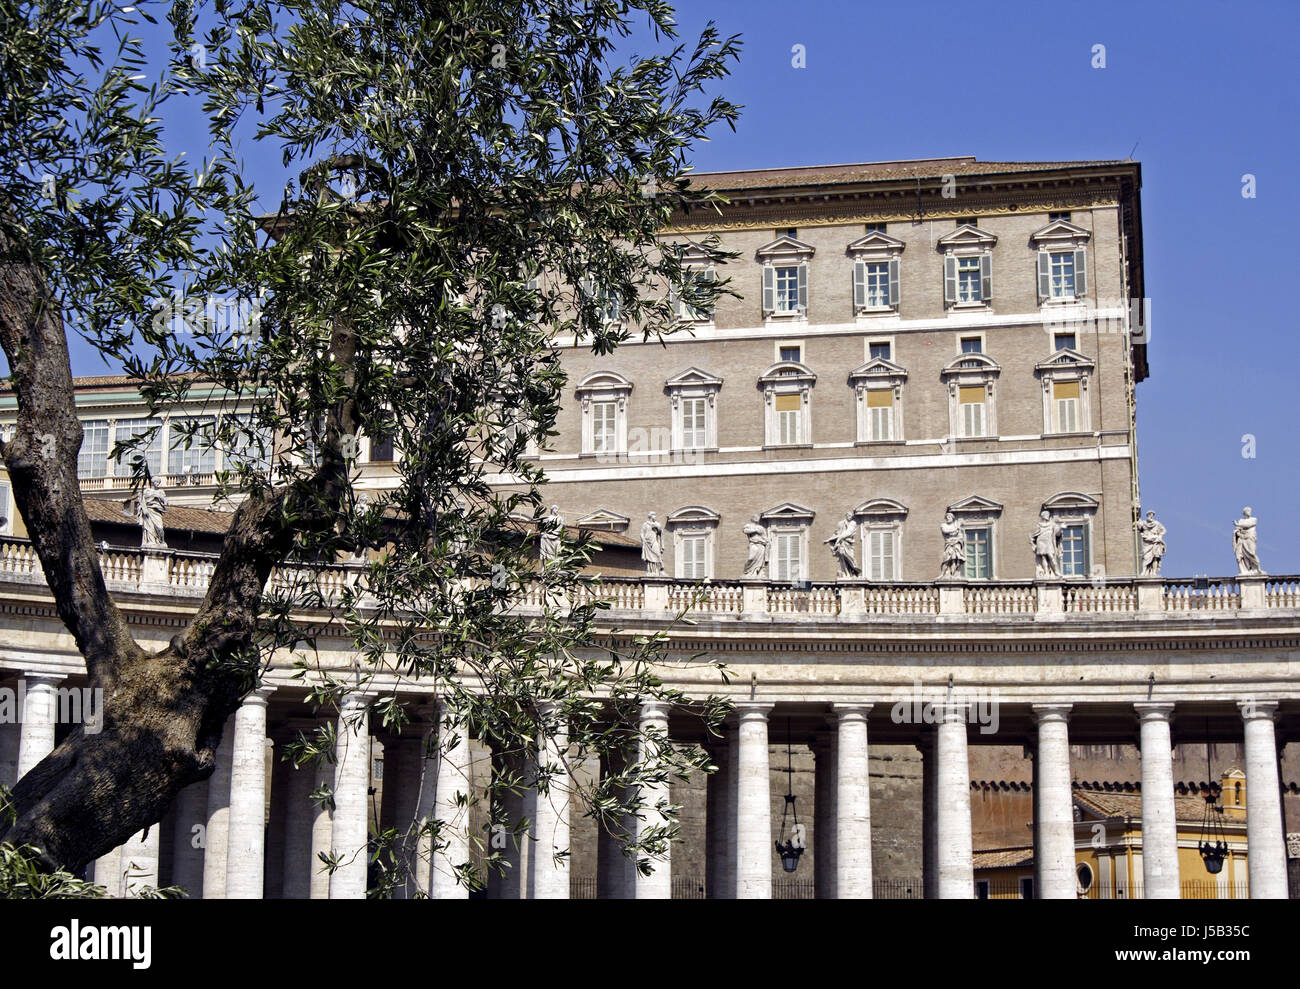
0;0;738;893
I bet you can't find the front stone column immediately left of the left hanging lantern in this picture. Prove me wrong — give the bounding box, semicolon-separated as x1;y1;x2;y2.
736;702;775;899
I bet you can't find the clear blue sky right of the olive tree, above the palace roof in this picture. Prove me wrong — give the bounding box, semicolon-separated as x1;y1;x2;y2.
63;0;1300;576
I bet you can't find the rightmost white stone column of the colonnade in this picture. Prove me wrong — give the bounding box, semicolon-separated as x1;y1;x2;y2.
1238;700;1290;899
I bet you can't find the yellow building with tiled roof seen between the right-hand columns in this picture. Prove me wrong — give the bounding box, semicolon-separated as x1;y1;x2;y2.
974;769;1249;899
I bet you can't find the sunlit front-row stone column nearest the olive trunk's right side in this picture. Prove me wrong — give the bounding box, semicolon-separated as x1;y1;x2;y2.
226;686;276;899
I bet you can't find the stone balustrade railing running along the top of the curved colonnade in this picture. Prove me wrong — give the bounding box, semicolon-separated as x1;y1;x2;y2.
0;538;1300;621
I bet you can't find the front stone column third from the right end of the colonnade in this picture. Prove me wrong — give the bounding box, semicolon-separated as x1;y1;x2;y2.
1034;704;1075;899
